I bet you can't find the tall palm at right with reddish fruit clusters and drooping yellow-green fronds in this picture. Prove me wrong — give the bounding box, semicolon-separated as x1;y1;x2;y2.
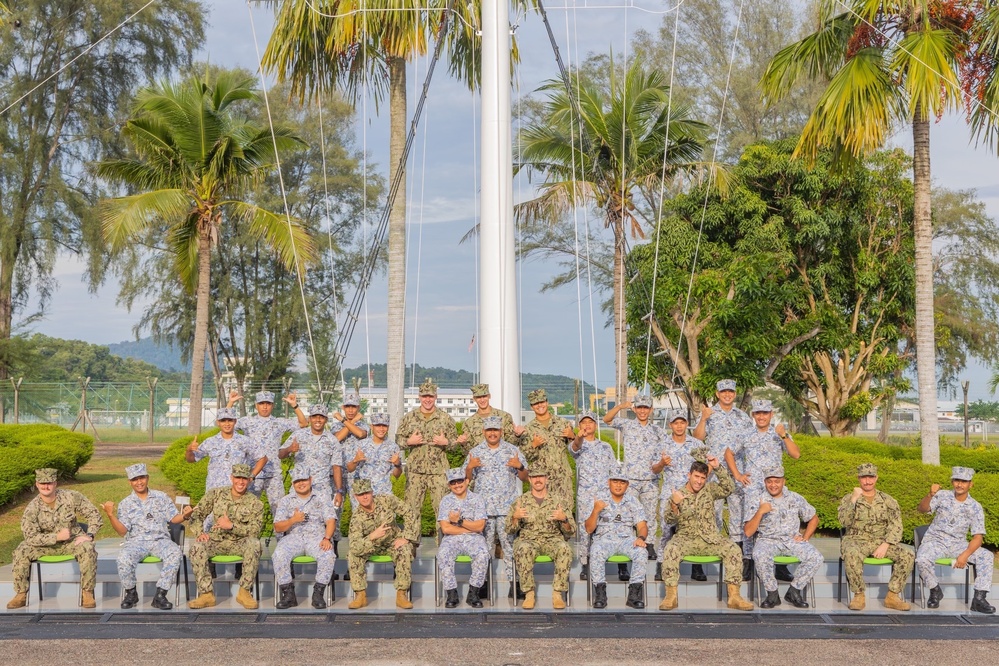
760;0;973;465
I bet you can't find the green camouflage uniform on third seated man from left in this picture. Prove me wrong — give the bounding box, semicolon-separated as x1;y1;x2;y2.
188;487;264;594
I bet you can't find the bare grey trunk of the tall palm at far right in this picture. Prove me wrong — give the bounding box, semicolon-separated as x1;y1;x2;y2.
912;109;940;465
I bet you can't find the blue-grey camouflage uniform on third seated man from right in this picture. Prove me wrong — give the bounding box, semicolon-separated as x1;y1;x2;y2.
745;482;822;592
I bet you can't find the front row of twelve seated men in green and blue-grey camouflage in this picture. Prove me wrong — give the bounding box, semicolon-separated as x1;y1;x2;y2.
7;452;994;613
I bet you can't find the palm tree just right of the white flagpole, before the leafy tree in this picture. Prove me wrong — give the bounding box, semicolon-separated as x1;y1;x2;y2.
514;60;707;408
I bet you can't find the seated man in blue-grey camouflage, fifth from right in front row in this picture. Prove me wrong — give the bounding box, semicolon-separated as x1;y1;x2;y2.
584;466;649;609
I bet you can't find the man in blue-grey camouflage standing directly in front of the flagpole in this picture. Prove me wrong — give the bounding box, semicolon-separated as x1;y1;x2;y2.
465;415;527;599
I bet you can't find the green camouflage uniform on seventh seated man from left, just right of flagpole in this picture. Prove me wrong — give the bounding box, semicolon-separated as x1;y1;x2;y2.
506;488;576;592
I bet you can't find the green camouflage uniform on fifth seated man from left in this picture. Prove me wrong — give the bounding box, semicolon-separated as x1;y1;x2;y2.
347;495;420;592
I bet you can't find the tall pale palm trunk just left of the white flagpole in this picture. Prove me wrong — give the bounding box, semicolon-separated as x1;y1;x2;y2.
385;58;408;437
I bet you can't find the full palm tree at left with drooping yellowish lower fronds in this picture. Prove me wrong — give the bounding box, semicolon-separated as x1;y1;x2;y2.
97;72;315;434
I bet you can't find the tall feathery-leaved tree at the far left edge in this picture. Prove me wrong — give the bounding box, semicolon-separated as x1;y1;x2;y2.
0;0;204;378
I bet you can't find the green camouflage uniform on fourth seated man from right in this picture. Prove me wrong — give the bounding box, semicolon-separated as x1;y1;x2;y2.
662;467;742;587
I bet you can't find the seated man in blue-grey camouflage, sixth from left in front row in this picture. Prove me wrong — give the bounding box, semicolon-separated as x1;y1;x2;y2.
437;467;489;608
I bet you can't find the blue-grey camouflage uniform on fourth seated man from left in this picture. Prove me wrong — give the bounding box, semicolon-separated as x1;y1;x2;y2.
271;490;336;585
